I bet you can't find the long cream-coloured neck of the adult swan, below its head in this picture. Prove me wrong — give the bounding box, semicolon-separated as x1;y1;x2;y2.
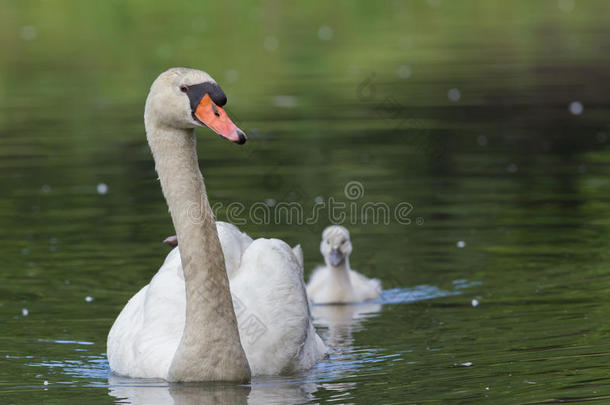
146;117;250;381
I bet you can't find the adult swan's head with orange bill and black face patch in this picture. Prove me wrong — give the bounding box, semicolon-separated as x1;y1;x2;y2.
144;68;247;145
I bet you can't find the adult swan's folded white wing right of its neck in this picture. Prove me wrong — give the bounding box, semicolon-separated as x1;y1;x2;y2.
230;239;326;375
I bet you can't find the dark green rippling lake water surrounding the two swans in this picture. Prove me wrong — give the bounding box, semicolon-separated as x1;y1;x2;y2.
0;0;610;404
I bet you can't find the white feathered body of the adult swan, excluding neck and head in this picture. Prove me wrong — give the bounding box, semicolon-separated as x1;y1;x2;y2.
108;221;327;379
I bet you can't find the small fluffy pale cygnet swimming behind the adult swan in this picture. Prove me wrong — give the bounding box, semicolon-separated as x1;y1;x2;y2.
307;225;381;304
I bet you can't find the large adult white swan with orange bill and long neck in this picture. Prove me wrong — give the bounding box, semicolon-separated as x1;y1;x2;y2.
107;68;326;382
